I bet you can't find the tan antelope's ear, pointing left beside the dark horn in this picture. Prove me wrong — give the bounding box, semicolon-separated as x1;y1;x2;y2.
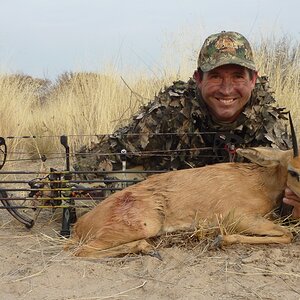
237;147;292;167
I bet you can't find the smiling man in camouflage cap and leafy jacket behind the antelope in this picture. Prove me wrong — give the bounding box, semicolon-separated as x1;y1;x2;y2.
77;31;300;217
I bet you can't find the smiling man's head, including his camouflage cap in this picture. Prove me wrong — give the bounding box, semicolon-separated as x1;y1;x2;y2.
194;31;257;123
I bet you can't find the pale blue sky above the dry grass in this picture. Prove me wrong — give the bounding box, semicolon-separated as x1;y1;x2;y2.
0;0;300;80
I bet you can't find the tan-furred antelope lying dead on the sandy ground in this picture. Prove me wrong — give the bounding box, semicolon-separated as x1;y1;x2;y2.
66;148;300;257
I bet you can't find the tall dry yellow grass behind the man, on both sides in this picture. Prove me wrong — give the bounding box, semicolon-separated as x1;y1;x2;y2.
0;37;300;162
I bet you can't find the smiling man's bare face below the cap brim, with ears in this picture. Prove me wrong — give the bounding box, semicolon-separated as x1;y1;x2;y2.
194;64;257;122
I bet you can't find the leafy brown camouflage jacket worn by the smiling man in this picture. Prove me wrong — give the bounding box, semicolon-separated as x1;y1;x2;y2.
75;77;290;171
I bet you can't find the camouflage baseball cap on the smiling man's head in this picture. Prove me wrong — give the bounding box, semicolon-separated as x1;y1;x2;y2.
198;31;256;72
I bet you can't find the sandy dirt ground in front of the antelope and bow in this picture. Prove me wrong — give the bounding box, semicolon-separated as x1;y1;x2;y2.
0;161;300;300
